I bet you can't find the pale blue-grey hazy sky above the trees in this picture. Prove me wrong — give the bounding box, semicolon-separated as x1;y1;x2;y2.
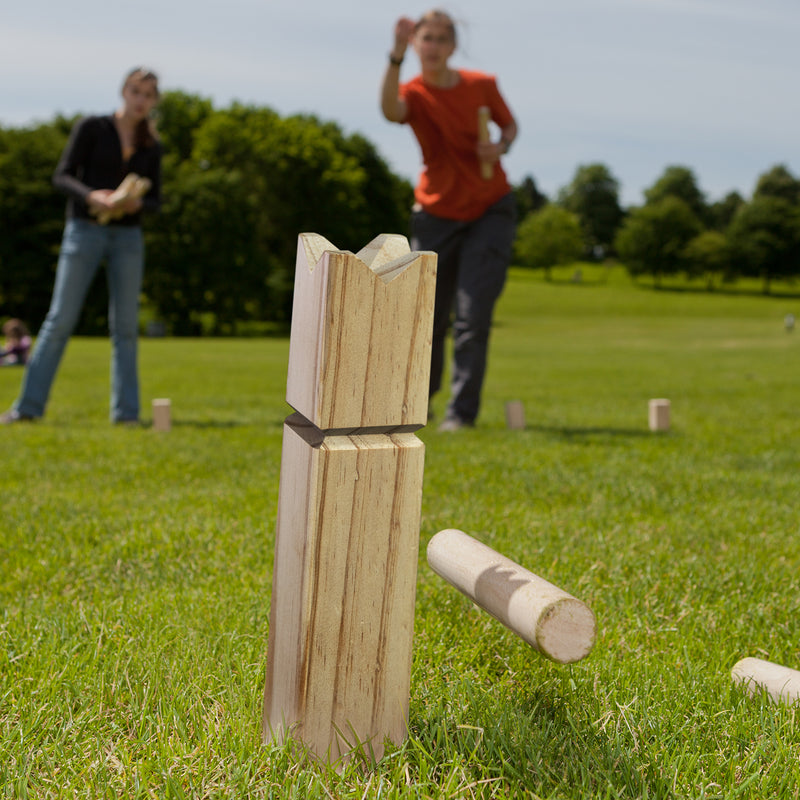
0;0;800;206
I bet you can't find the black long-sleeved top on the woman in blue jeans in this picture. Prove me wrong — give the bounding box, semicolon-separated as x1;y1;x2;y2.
53;115;161;225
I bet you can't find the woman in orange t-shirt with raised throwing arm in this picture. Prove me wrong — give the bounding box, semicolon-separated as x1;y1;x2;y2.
381;10;517;431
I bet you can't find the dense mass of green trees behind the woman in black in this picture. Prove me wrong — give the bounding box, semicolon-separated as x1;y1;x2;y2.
0;91;413;335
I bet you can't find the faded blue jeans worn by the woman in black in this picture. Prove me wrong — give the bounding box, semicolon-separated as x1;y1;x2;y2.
14;219;144;422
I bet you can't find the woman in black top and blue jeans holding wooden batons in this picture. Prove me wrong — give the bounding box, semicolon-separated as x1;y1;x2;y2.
2;67;161;423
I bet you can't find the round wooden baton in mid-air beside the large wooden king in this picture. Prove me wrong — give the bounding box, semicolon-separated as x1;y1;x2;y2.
428;529;597;664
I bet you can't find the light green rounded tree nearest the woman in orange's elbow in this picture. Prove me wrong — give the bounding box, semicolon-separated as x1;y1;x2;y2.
514;203;583;280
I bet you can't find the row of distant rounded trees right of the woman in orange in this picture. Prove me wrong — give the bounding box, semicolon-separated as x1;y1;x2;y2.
515;164;800;292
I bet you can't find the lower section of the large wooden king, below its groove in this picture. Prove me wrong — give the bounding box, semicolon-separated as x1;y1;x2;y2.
264;414;424;761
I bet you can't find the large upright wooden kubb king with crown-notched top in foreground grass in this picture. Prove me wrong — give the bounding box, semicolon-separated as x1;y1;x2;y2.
263;234;436;761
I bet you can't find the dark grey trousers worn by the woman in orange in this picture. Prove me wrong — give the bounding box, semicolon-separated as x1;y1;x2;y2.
411;194;517;423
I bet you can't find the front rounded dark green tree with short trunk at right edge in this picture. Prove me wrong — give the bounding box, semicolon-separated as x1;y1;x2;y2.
728;194;800;293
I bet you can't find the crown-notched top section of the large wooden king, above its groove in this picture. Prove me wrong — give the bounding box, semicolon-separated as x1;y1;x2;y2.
286;233;436;430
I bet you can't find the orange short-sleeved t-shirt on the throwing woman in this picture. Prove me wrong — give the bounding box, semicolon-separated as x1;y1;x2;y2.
400;70;514;220
